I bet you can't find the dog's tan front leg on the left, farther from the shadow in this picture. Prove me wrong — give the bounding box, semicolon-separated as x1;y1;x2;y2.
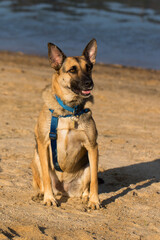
38;141;57;206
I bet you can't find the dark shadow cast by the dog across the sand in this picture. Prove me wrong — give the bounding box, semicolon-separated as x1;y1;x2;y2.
98;159;160;206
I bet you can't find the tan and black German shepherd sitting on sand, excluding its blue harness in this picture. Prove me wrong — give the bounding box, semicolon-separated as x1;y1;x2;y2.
31;39;100;209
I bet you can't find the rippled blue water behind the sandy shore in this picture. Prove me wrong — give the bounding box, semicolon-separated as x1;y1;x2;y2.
0;0;160;69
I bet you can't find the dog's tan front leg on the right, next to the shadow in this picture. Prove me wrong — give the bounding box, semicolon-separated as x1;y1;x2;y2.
88;145;100;209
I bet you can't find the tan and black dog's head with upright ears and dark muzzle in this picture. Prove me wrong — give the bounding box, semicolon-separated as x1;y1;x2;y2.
48;39;97;98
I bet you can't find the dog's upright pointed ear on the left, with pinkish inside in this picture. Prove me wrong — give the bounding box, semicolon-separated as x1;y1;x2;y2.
48;43;66;71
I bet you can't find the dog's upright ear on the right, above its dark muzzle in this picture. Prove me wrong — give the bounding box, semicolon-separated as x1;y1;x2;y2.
83;39;97;64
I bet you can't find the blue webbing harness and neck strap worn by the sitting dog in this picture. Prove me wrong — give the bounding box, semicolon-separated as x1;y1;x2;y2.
49;95;90;172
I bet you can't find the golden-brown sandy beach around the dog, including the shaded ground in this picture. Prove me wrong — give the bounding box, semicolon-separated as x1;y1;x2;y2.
0;52;160;240
